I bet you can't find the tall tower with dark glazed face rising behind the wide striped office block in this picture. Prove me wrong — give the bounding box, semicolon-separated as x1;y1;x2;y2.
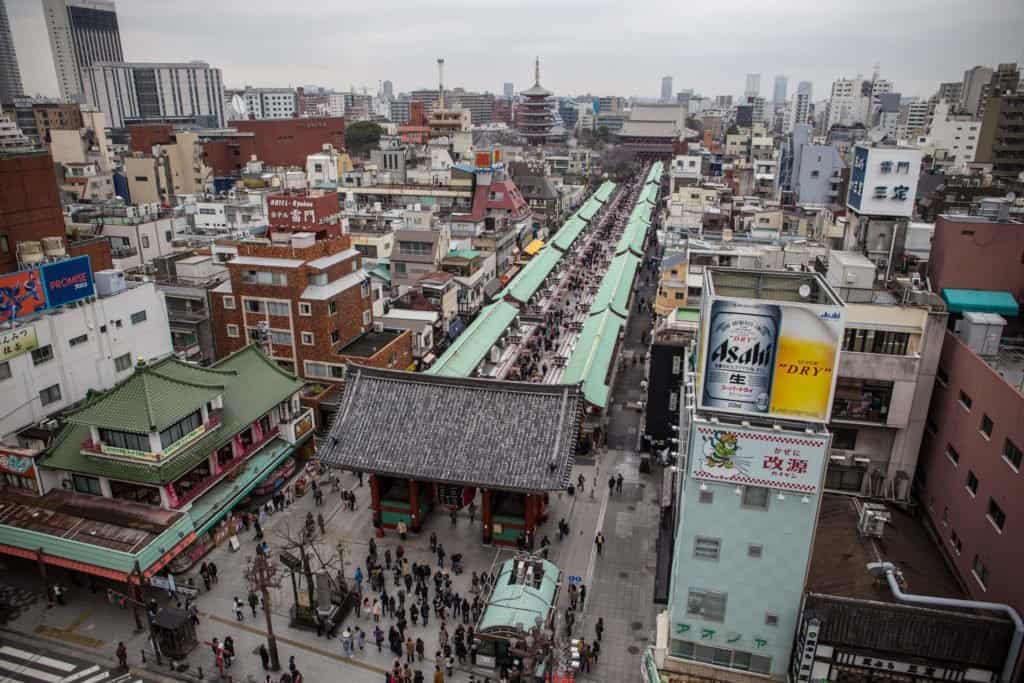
43;0;127;99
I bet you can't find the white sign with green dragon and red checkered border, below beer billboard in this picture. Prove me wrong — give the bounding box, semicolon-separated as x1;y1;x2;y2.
689;422;829;494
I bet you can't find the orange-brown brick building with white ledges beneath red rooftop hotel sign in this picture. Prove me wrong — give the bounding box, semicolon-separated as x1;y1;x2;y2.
210;232;413;381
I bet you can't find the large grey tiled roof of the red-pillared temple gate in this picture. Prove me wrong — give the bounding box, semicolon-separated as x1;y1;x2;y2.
316;366;581;492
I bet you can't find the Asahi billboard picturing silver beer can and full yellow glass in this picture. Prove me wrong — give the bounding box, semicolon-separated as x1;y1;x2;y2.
697;296;844;422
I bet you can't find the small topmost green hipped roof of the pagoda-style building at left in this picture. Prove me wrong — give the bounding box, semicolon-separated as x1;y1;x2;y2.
69;358;227;433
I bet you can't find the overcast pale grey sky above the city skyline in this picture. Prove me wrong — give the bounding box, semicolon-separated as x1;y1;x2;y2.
6;0;1024;99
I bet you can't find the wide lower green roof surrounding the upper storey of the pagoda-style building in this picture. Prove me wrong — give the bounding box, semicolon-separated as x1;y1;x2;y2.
41;345;302;484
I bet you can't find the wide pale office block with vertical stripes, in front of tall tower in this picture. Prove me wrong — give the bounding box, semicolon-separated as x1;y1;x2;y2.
83;61;224;128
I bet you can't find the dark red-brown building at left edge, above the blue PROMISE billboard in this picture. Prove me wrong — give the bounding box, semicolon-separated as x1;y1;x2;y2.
0;152;65;272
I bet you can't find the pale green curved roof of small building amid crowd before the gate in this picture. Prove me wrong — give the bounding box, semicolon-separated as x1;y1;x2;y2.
476;560;559;633
